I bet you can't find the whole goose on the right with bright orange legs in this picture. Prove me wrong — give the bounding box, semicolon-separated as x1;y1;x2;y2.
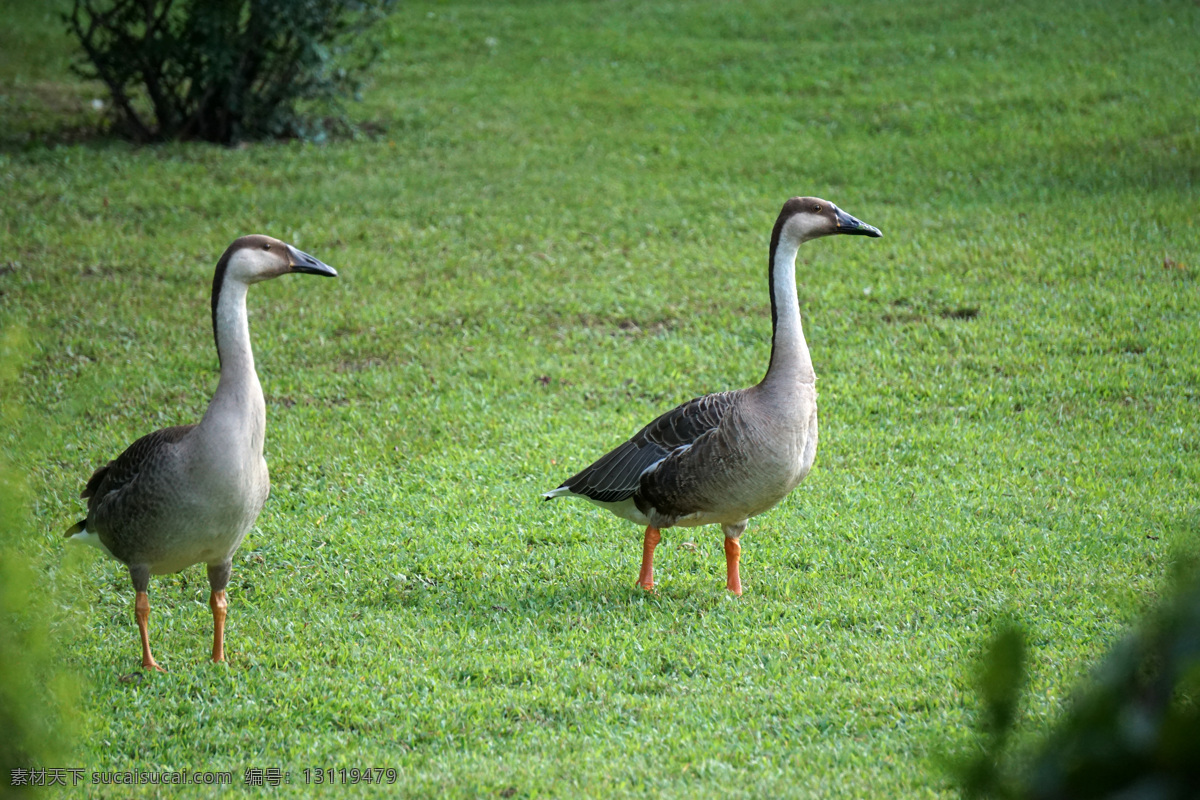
542;197;883;595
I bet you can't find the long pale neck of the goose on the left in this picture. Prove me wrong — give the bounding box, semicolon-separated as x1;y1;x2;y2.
200;279;266;453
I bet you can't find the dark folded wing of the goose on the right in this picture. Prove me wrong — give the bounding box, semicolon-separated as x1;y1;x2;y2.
546;392;736;503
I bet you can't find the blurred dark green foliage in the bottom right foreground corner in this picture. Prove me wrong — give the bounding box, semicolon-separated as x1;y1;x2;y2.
960;577;1200;800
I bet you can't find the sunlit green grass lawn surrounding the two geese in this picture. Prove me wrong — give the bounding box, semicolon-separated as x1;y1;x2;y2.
0;0;1200;798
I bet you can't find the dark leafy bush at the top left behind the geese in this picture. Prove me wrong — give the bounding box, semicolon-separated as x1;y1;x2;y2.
66;0;396;144
